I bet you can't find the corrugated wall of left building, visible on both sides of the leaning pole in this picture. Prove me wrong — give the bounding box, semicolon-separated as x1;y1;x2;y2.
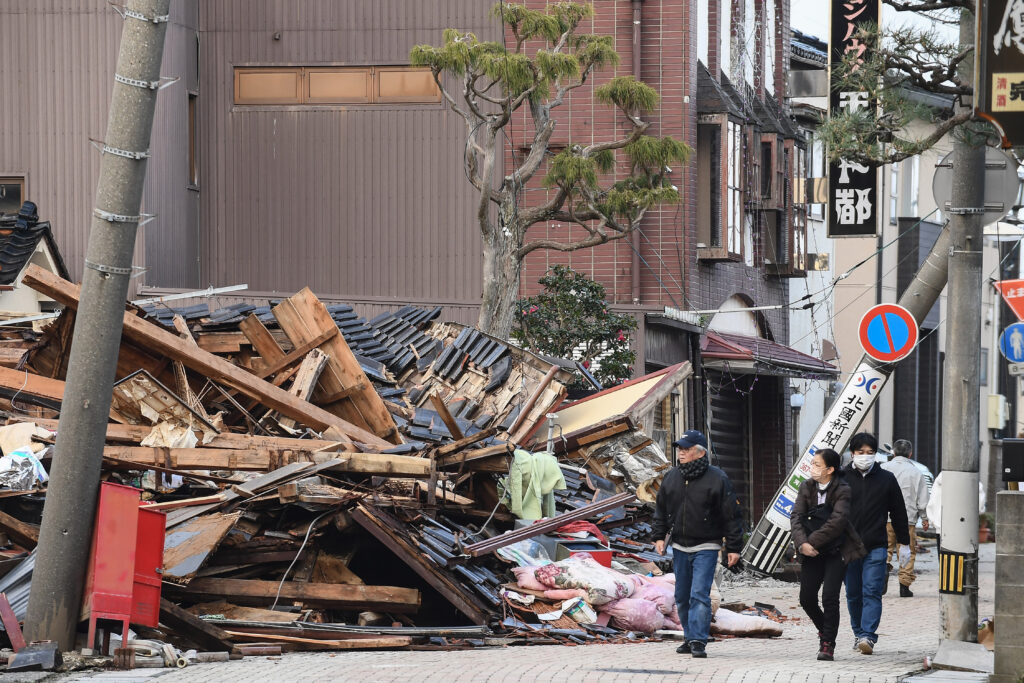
0;0;199;287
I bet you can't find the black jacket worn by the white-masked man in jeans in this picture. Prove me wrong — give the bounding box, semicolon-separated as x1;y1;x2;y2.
843;463;910;550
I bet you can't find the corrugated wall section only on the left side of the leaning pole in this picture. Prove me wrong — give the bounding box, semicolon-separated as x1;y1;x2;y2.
0;0;122;278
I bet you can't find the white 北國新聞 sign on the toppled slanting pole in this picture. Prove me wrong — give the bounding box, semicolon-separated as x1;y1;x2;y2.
743;362;892;573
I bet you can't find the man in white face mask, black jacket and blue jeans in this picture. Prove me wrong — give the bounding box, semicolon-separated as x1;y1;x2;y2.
845;432;910;654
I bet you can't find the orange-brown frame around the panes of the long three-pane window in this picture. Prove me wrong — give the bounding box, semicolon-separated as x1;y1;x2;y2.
233;65;441;108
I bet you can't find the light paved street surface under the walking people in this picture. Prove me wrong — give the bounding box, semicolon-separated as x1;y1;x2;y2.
44;542;995;683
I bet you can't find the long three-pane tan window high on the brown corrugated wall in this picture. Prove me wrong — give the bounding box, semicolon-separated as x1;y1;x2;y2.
234;67;441;104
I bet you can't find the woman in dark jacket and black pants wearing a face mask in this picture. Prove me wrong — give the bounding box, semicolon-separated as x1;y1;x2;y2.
790;449;866;661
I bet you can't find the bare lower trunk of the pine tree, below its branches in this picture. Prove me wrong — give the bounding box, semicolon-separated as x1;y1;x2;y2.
477;225;522;339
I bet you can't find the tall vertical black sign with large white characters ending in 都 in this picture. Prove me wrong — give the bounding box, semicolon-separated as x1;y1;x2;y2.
828;0;880;238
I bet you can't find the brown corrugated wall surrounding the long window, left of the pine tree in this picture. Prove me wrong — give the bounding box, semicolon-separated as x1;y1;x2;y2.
200;0;500;304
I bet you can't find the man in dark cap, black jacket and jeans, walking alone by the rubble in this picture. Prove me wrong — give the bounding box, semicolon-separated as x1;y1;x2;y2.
653;429;743;657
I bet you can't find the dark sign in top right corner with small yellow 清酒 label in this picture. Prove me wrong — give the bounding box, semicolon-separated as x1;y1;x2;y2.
975;0;1024;146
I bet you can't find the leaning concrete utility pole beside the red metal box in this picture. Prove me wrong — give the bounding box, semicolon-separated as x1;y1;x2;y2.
25;0;170;650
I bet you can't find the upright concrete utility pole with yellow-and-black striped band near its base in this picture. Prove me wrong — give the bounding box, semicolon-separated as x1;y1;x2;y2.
939;11;985;642
